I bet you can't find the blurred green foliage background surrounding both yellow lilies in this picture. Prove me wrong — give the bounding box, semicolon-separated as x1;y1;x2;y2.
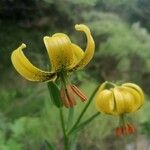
0;0;150;150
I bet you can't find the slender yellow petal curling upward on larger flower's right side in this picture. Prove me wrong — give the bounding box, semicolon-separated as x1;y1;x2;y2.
72;24;95;70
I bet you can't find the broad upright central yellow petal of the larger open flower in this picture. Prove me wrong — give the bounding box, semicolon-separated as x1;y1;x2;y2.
44;33;74;72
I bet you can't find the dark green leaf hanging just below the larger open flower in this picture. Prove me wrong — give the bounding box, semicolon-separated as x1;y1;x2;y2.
47;82;63;107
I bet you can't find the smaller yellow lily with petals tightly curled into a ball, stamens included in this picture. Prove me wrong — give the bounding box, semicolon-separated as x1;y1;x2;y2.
95;82;144;136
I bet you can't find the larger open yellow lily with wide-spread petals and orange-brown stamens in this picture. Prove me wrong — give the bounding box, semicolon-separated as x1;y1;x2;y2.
11;24;95;107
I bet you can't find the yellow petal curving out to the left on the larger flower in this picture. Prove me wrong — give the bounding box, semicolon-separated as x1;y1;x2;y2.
11;44;56;82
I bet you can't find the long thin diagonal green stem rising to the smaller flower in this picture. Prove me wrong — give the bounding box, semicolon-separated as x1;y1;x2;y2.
68;86;99;135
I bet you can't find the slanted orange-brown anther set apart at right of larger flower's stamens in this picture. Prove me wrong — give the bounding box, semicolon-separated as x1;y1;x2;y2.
70;85;87;102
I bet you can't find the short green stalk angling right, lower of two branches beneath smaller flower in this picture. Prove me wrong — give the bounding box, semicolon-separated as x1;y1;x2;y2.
70;112;100;134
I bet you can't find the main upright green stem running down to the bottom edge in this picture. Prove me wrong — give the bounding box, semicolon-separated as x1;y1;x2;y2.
59;108;69;150
